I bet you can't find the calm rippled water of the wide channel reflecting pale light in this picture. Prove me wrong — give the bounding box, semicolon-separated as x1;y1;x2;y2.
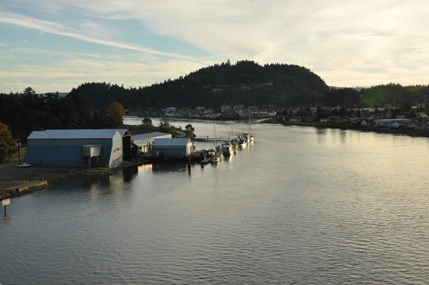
0;118;429;285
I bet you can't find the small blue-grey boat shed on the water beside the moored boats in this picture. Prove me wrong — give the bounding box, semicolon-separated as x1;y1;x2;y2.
152;138;193;157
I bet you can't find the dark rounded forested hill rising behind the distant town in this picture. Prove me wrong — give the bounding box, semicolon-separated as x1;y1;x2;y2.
76;60;329;110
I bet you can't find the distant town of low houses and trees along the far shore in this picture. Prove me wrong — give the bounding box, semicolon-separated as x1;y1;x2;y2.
126;105;429;135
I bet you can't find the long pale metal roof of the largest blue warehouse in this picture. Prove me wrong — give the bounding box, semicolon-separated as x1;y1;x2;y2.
27;129;129;140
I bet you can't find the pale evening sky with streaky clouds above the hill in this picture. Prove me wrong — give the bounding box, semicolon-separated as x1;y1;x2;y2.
0;0;429;93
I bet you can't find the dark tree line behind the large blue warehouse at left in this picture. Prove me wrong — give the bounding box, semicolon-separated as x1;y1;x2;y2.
0;87;125;141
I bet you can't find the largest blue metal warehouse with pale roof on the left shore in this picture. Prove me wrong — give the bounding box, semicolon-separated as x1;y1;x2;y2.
24;129;132;168
